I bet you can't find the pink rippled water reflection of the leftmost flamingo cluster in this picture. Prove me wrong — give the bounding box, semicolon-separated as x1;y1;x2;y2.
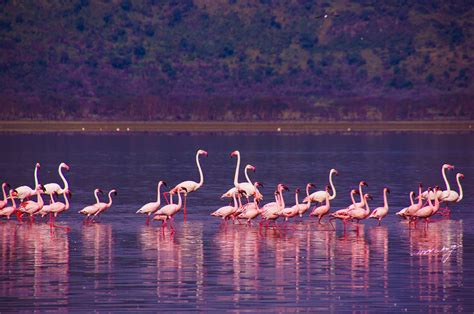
0;221;69;306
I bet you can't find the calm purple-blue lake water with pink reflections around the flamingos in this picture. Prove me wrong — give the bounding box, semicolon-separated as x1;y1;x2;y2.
0;134;474;312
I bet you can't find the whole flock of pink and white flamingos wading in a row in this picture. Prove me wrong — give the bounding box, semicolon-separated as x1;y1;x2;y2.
0;150;464;232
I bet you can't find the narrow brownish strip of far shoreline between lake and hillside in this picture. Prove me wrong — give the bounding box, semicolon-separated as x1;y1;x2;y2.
0;120;474;133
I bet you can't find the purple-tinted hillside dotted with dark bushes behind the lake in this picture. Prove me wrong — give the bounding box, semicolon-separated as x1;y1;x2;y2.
0;0;474;120
